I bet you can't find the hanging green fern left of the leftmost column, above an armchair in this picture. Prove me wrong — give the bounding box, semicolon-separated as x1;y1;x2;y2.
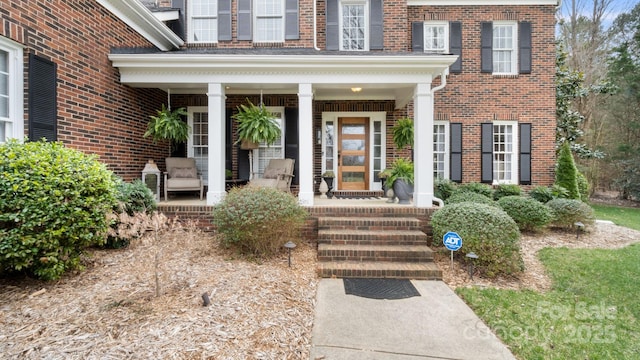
144;104;191;142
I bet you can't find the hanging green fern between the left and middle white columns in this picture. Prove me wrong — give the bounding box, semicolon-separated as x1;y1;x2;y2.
232;99;281;146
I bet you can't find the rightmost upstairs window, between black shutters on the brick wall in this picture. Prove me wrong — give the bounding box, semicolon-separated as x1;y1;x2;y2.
493;22;518;74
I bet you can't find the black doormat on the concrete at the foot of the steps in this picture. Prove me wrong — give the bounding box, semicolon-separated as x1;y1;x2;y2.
342;278;420;300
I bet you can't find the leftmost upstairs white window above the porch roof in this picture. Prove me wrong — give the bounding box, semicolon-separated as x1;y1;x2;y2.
189;0;218;43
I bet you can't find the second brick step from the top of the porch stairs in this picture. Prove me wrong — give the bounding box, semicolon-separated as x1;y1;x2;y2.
318;229;428;245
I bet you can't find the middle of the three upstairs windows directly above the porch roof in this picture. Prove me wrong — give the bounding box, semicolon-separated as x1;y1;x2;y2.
253;0;285;42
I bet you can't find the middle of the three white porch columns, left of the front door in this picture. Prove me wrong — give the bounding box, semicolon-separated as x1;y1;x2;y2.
294;84;313;206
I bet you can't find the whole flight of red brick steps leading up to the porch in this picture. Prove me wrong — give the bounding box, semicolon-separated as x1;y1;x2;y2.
318;215;442;280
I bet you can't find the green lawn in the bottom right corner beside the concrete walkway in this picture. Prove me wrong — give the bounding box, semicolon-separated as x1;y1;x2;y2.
458;243;640;360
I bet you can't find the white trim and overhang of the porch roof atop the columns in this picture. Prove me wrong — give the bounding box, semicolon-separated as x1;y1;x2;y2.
109;53;457;108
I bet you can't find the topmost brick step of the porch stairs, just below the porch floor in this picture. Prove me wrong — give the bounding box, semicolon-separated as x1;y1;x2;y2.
318;217;422;230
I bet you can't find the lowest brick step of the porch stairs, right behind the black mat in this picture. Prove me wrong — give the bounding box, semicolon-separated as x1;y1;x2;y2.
318;261;442;280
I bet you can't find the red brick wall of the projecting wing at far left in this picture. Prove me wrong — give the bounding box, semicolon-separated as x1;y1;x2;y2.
0;0;169;180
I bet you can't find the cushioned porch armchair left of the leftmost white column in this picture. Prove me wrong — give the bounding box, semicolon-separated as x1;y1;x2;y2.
164;158;204;201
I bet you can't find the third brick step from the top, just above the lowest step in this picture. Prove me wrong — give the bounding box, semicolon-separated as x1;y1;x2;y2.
318;244;433;262
